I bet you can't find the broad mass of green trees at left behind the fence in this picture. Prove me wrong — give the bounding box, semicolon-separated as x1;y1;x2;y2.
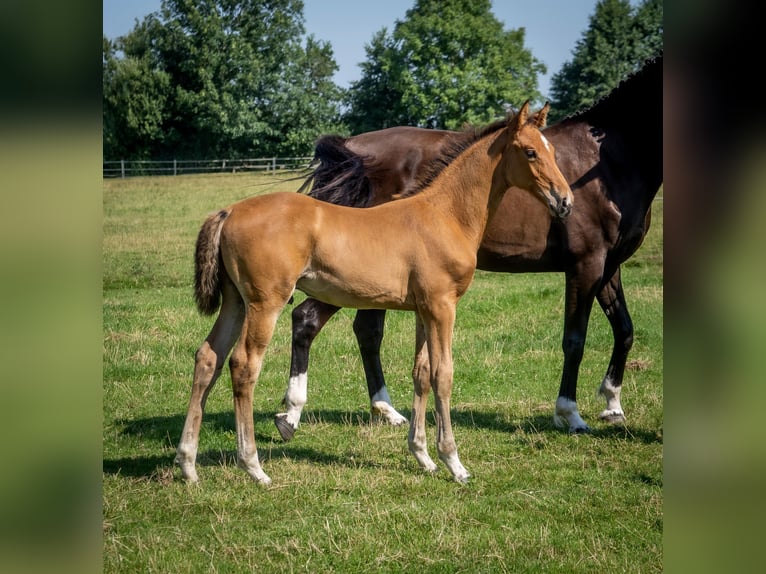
104;0;342;158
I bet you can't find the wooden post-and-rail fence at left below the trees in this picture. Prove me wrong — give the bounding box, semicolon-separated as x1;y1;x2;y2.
103;157;312;178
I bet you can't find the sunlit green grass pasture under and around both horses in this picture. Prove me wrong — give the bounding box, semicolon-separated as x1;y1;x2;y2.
102;174;663;574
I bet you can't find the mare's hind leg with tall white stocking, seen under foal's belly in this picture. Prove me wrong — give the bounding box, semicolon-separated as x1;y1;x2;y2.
274;298;340;441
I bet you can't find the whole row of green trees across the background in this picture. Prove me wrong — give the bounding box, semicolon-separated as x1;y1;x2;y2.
102;0;663;160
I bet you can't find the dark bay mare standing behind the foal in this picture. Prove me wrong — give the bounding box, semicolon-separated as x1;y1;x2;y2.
276;56;662;440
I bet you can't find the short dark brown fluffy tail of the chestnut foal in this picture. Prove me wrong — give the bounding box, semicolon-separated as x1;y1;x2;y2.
194;209;230;315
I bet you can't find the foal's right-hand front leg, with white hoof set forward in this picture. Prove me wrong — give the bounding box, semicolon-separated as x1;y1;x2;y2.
422;300;470;482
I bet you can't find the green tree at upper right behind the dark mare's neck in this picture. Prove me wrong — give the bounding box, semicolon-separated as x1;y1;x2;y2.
549;0;663;121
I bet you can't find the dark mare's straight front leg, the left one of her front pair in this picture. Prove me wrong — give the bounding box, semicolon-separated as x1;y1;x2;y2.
553;261;603;433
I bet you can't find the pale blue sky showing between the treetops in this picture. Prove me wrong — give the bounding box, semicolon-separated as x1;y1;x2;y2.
103;0;640;96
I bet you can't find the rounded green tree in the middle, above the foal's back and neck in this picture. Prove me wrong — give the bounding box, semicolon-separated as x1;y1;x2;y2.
345;0;546;133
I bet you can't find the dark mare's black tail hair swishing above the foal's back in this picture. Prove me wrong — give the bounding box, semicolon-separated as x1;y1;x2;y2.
298;135;370;207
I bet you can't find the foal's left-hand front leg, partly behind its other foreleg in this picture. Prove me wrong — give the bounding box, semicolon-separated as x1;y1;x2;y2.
407;314;437;472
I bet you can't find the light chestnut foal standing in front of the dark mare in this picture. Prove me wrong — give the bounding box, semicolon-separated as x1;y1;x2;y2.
176;102;572;484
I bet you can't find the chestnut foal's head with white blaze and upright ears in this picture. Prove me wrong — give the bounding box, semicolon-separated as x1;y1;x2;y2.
503;100;574;219
